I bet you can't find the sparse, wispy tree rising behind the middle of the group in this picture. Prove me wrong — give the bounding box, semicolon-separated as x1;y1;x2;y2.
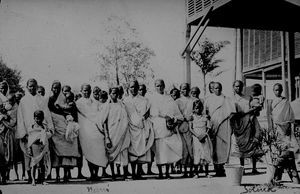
97;17;155;89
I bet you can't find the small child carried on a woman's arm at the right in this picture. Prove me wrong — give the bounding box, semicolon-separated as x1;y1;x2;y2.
249;84;265;116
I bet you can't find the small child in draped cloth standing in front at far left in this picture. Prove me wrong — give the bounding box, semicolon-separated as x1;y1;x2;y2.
27;110;52;186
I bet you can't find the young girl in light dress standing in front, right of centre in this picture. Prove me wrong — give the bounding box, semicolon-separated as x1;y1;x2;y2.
190;100;212;177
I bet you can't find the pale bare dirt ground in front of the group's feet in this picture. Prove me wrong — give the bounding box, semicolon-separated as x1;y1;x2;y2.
0;163;300;194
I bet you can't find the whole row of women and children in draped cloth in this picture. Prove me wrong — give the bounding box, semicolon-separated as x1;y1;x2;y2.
0;79;299;185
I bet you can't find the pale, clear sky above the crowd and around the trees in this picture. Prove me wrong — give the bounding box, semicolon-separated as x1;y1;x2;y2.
0;0;235;97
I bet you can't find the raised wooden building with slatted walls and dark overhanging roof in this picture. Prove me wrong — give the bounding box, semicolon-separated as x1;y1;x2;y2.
182;0;300;100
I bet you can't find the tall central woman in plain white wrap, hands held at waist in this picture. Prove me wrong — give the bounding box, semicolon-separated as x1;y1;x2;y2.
150;80;183;179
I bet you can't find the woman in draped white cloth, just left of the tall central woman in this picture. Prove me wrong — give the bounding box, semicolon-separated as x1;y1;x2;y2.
124;81;154;179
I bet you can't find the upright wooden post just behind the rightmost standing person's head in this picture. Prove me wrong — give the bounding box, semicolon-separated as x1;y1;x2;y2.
280;31;289;98
